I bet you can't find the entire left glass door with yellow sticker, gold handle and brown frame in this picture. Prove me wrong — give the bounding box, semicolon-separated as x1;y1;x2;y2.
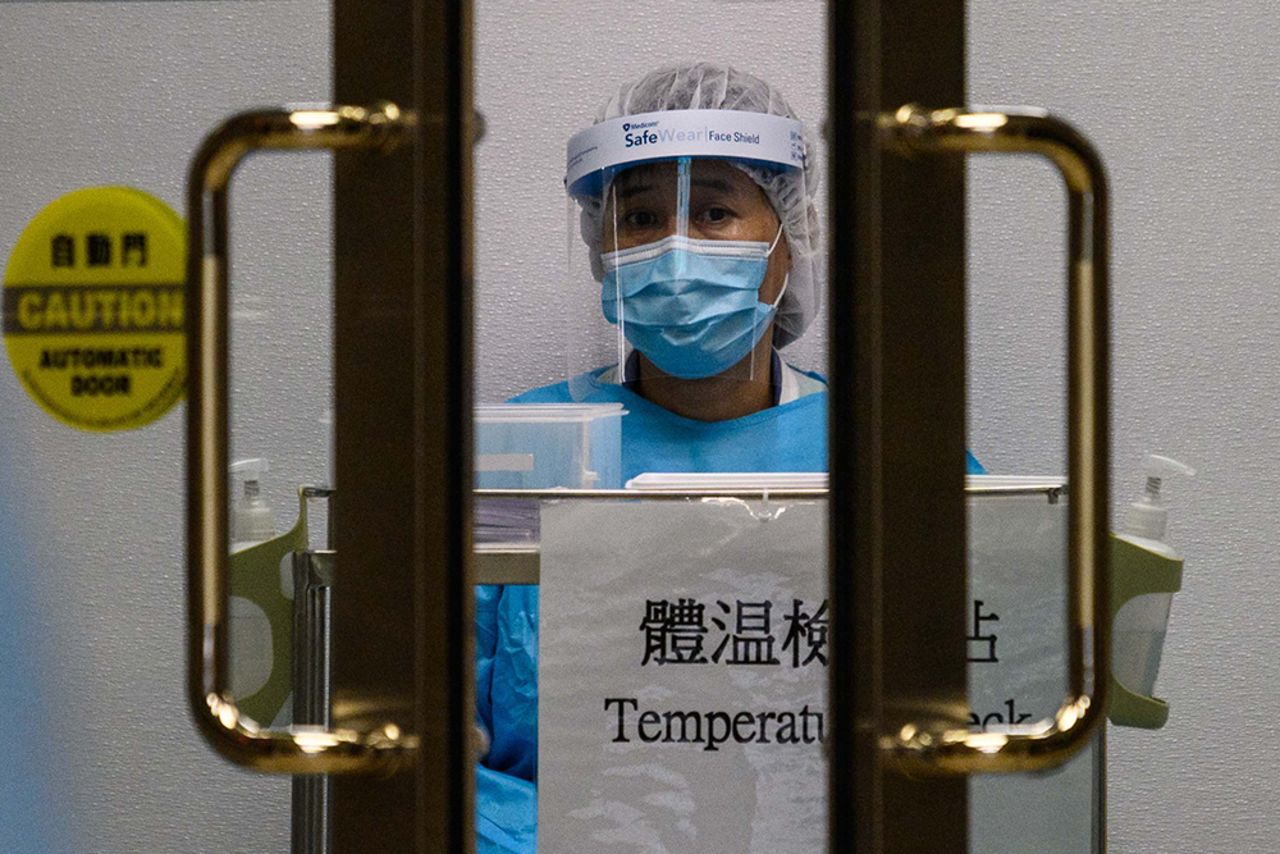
0;3;475;851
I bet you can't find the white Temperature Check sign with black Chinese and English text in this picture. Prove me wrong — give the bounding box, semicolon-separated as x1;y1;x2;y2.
538;490;1094;854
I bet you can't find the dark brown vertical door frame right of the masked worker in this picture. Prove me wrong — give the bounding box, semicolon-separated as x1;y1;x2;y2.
828;0;969;854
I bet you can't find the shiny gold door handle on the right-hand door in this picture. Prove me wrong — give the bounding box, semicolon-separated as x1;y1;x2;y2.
879;105;1111;773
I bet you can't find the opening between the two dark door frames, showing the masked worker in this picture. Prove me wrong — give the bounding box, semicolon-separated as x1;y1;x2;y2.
475;0;828;851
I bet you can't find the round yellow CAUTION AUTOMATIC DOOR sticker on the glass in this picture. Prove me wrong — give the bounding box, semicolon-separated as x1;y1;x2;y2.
4;187;187;431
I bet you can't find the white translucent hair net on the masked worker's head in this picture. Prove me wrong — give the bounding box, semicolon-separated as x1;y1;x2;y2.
577;63;826;347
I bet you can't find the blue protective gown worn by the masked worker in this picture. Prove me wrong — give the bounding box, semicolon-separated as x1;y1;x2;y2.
476;362;983;854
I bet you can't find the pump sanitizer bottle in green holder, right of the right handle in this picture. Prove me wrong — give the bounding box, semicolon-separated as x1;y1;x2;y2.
1111;453;1196;697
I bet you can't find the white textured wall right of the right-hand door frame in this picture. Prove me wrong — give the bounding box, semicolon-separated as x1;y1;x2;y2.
969;0;1280;854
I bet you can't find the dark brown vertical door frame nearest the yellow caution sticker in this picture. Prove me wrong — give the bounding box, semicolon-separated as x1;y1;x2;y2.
333;0;475;854
